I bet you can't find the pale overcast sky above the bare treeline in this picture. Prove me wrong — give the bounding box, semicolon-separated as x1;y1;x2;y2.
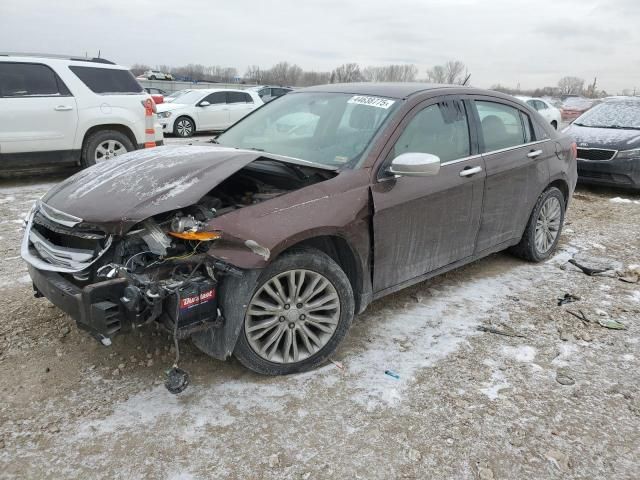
0;0;640;93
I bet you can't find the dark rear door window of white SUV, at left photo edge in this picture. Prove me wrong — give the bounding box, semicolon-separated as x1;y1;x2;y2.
0;62;63;97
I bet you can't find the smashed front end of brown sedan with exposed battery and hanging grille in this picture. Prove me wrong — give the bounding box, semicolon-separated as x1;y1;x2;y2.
22;202;236;344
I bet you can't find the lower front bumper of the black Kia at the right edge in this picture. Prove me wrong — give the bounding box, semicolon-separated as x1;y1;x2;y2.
578;158;640;189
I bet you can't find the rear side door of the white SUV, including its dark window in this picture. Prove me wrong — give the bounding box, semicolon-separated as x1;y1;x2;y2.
0;62;78;154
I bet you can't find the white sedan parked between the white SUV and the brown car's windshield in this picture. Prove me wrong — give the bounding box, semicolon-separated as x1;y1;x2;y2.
158;89;264;137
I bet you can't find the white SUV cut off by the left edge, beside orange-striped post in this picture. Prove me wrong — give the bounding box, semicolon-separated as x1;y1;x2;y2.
0;54;163;170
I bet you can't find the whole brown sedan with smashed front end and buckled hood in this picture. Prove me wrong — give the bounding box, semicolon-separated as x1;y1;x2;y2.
22;83;577;374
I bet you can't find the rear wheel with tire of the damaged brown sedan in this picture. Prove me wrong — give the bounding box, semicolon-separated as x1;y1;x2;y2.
510;187;566;262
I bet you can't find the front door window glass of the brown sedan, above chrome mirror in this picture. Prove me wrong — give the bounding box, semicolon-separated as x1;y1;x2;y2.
393;100;471;162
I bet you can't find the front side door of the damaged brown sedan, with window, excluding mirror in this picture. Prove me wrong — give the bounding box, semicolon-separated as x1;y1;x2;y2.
372;96;485;292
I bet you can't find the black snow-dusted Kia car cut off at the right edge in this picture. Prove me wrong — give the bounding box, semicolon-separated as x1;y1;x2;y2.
566;98;640;189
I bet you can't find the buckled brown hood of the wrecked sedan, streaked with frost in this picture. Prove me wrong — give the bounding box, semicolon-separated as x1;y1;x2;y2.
42;145;264;233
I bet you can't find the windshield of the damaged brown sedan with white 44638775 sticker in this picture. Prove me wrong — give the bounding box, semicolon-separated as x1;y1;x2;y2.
217;92;400;167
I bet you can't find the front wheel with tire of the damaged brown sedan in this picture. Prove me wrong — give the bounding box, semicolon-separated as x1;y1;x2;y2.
233;249;354;375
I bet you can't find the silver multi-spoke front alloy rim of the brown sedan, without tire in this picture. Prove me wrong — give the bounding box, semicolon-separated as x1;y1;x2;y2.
244;269;340;363
